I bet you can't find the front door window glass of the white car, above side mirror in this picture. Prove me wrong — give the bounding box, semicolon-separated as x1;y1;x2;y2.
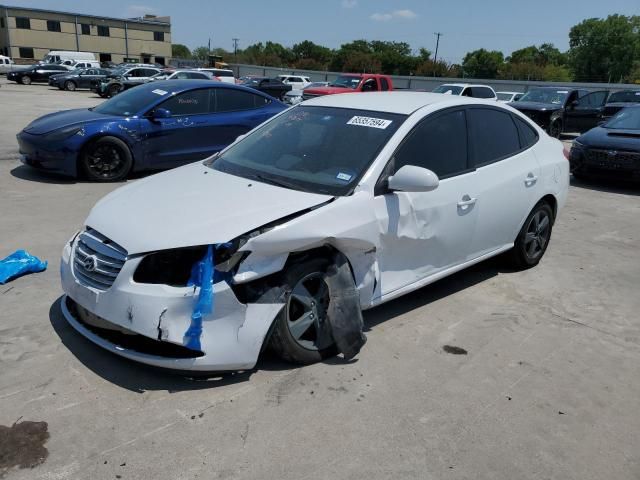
394;110;468;178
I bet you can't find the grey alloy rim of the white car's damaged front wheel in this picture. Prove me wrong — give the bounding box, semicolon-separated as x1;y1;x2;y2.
285;272;333;350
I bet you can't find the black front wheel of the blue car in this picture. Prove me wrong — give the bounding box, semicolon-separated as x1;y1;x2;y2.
80;137;133;182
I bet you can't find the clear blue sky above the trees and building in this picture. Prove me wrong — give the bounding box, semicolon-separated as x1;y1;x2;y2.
6;0;640;63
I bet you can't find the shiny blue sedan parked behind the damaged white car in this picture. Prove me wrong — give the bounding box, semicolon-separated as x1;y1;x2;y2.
17;80;288;181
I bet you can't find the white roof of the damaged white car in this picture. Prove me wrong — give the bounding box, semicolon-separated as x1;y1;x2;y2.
304;91;498;115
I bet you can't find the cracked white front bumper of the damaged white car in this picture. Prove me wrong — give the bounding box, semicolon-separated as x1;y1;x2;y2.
60;236;283;372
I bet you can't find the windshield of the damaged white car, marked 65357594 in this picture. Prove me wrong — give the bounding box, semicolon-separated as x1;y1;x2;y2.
212;105;406;196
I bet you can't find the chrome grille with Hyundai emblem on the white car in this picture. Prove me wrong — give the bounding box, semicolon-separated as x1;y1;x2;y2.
73;228;127;291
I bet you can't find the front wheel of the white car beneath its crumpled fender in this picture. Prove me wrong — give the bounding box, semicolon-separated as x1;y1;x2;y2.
270;259;337;365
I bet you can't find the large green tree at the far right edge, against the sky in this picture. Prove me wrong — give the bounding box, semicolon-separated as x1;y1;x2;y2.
569;15;640;82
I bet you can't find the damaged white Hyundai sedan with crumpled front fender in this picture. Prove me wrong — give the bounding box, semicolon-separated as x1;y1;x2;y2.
61;92;569;371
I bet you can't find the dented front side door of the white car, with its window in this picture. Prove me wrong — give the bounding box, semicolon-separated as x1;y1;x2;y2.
374;108;477;295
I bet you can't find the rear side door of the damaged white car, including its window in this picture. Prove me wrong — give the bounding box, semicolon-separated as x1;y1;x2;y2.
467;106;540;257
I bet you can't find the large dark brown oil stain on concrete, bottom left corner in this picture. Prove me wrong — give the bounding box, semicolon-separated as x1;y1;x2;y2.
0;421;49;478
